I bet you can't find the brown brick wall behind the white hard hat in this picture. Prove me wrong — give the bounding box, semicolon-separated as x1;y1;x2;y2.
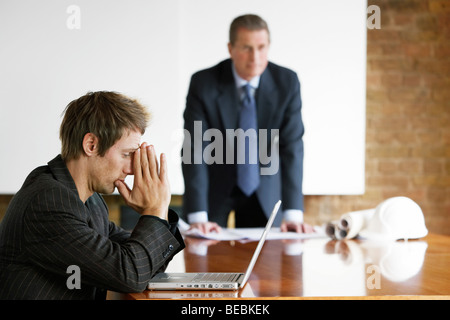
305;0;450;234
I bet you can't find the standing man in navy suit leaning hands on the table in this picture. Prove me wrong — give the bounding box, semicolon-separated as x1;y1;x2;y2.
182;14;312;232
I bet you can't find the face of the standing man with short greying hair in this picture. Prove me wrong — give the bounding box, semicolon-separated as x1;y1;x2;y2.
228;28;270;80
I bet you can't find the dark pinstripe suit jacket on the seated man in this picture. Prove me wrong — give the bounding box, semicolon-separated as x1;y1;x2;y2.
0;156;184;299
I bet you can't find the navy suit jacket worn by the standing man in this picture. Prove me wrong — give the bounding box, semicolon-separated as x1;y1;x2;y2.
182;59;304;225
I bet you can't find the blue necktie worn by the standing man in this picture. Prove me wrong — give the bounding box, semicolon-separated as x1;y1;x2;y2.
237;84;259;196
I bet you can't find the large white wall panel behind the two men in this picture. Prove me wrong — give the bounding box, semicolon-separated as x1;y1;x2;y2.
0;0;367;194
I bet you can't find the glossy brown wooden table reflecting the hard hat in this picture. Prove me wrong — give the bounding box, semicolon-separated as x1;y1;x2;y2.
109;234;450;299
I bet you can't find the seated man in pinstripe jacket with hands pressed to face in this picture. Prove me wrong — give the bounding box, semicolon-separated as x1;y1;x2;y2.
0;92;184;299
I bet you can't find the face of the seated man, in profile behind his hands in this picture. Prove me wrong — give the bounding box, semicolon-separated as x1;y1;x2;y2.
91;131;142;194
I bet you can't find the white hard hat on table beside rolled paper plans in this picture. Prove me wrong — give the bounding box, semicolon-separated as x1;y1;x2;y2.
359;197;428;240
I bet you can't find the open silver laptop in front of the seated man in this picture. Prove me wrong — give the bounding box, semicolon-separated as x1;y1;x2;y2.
148;200;281;290
